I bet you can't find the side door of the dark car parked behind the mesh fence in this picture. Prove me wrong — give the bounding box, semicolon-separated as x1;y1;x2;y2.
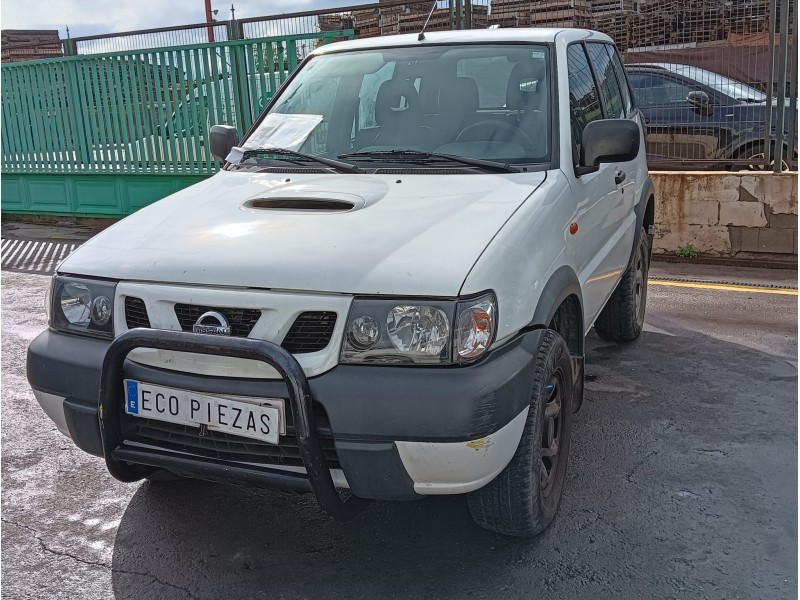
629;70;729;160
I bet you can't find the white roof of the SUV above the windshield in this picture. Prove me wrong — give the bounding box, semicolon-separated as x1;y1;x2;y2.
312;27;613;55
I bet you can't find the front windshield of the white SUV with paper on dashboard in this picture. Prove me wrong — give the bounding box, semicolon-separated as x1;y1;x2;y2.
243;45;550;163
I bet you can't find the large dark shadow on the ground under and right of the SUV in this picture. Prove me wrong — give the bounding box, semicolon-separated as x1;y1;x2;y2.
112;322;797;600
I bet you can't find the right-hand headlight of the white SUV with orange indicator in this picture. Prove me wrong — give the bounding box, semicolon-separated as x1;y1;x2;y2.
341;293;497;365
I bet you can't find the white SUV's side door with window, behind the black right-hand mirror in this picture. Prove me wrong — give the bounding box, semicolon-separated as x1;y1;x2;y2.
565;43;636;325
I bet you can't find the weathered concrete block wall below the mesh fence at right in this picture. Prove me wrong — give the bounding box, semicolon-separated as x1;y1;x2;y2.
650;171;797;260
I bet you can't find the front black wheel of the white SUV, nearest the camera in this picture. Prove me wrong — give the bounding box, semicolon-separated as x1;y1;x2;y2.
467;330;573;537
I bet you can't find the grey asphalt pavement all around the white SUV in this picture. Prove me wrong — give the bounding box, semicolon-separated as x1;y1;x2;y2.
1;265;798;600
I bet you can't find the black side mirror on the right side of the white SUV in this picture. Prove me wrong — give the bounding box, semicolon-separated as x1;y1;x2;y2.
575;119;641;175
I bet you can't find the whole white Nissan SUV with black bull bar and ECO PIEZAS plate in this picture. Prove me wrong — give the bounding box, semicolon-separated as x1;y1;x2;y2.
28;29;653;536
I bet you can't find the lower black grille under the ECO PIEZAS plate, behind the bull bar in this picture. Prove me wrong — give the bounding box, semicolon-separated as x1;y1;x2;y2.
121;402;341;469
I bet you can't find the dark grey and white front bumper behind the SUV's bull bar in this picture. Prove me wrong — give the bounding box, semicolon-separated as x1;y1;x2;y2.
27;330;543;510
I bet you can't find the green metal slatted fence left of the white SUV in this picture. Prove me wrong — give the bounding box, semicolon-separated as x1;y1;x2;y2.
0;30;353;216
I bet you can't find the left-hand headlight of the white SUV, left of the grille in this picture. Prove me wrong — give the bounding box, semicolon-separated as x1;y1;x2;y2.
49;276;117;338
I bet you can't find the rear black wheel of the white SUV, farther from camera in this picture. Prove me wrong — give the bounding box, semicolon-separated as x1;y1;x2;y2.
594;228;650;342
